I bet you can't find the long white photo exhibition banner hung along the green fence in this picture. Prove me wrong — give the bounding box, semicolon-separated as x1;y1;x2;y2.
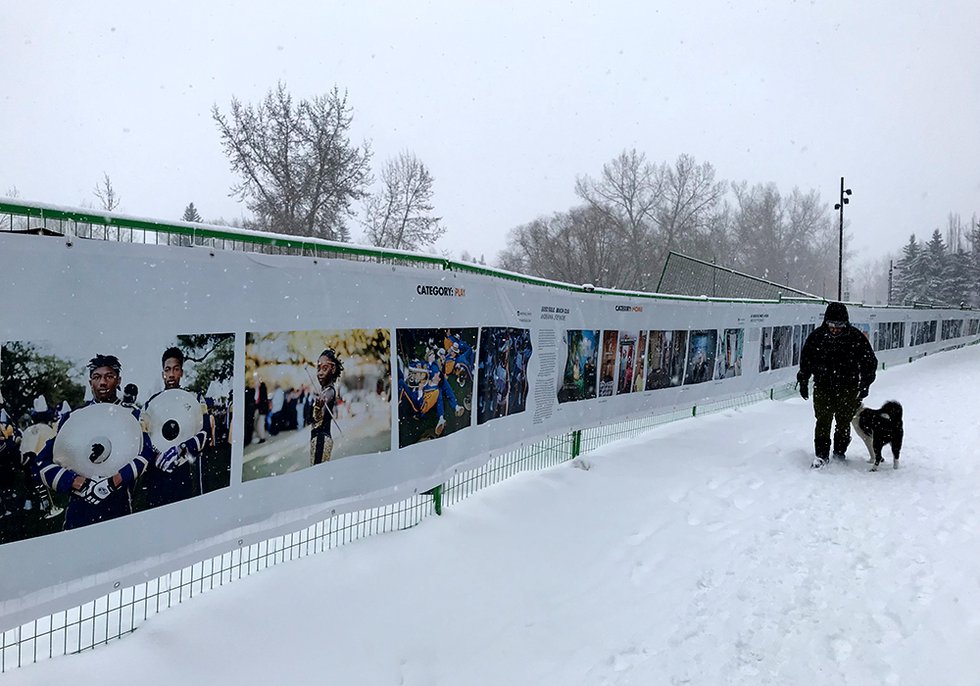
0;234;980;629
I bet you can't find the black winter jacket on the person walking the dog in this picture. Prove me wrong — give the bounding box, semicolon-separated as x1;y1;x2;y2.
796;324;878;391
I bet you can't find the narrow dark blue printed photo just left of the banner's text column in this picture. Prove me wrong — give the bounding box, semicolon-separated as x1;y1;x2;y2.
476;327;532;424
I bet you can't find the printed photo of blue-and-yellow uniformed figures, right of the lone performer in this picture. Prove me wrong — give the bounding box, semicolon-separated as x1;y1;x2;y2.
396;328;477;448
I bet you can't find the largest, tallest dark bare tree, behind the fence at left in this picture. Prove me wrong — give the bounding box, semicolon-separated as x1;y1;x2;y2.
211;82;371;241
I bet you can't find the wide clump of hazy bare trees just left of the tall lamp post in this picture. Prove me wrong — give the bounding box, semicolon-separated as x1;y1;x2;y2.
499;149;847;295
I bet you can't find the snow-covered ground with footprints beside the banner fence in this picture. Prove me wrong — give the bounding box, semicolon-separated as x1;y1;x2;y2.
7;346;980;686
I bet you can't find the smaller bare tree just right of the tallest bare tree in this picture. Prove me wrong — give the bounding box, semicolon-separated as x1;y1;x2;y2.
364;151;446;250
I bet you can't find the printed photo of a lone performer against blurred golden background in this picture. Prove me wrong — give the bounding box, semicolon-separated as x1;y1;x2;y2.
241;329;391;481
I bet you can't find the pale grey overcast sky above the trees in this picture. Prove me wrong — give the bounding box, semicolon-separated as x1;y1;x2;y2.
0;0;980;260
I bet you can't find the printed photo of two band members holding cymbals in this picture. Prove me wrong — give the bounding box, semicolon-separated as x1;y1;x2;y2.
0;332;235;543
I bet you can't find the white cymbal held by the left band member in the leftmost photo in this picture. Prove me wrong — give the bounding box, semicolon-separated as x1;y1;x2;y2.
54;403;143;480
